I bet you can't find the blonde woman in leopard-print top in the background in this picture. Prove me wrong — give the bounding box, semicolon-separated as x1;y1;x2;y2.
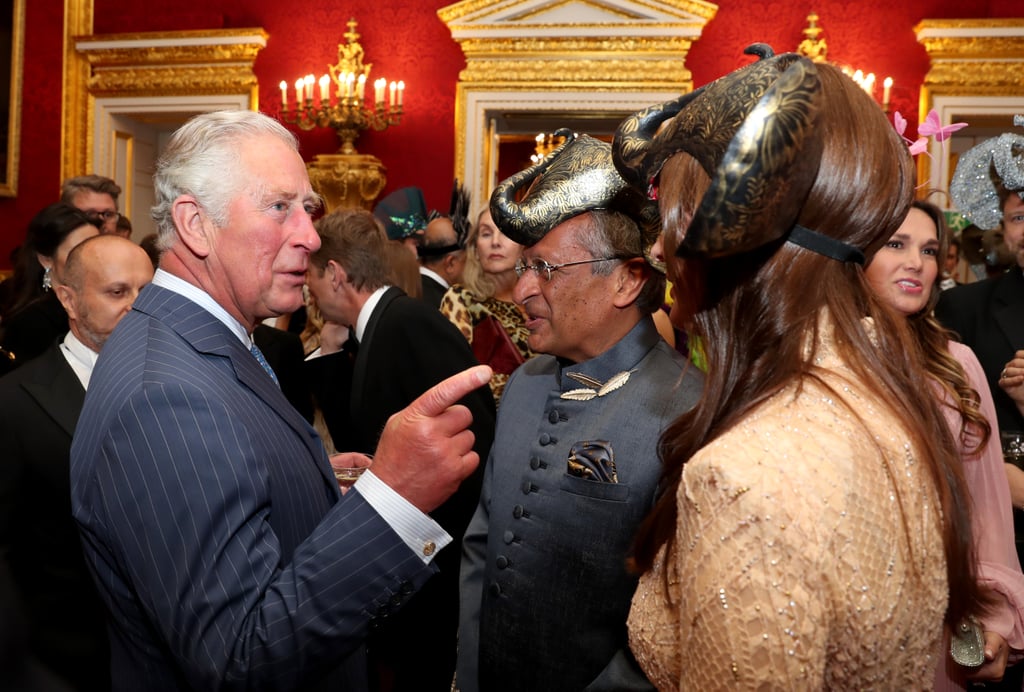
440;209;534;404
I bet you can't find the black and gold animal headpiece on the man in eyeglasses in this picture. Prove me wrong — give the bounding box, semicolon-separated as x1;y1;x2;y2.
490;129;665;271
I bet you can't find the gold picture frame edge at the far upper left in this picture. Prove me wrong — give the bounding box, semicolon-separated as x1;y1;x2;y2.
0;0;26;197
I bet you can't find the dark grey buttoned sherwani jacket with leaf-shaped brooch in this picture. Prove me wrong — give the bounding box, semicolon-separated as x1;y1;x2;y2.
457;317;702;692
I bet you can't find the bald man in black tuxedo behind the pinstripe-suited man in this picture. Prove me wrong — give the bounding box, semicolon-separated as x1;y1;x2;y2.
0;235;153;690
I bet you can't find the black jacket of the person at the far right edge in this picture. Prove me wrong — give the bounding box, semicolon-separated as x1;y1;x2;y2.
935;267;1024;431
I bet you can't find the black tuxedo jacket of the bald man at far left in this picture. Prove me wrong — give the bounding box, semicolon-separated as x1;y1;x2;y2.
0;343;110;690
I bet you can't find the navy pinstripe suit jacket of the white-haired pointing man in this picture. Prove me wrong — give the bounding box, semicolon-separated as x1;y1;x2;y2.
72;285;435;692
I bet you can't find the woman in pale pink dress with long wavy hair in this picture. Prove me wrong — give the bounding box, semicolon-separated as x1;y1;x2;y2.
864;201;1024;690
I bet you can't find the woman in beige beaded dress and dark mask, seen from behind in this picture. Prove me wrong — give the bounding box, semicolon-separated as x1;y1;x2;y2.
615;46;984;689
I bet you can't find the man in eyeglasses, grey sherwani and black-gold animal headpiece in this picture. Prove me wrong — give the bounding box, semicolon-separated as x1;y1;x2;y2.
456;133;702;692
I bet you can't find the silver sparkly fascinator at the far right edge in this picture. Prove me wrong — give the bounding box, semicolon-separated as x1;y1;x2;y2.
949;116;1024;230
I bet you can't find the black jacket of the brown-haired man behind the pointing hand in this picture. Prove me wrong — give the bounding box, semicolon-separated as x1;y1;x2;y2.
307;288;495;692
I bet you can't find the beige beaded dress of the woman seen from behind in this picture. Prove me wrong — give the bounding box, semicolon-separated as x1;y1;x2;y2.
629;321;947;690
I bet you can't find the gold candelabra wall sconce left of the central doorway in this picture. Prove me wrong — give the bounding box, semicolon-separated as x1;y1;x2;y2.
281;18;406;212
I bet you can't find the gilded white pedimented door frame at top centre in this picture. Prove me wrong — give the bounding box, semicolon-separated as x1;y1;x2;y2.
437;0;718;207
